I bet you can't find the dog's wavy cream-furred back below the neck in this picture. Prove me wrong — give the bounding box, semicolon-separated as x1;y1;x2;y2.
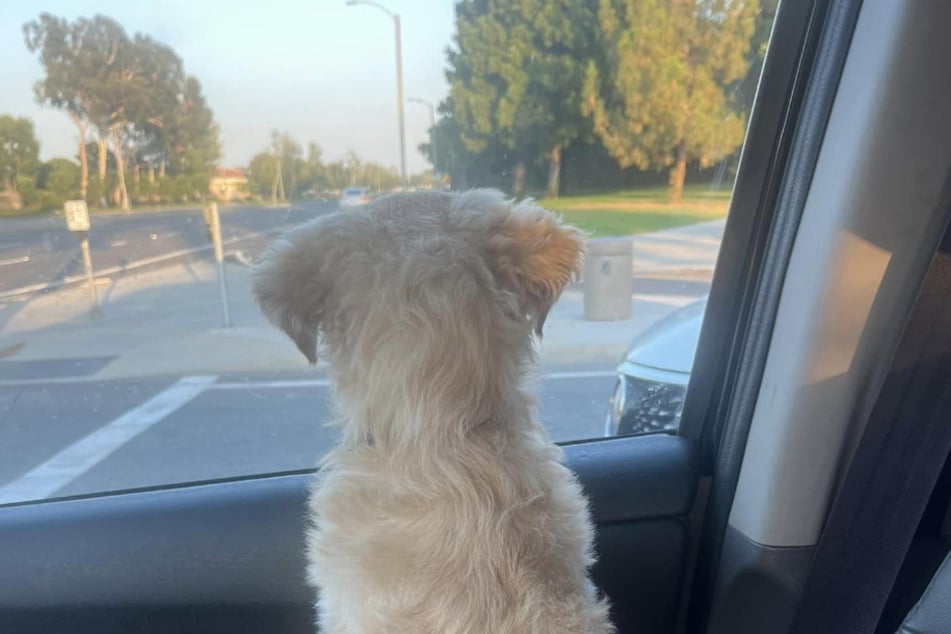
308;424;610;634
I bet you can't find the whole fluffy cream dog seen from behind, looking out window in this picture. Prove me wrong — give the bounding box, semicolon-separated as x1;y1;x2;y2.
254;190;613;634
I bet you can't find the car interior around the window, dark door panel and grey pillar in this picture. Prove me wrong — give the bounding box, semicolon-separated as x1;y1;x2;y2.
0;0;951;634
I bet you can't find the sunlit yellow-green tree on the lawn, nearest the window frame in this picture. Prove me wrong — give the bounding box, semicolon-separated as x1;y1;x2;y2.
583;0;758;201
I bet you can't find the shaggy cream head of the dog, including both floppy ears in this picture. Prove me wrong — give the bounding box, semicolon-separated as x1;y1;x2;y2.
254;190;583;365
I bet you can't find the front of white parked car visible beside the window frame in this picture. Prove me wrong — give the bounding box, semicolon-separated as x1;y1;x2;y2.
604;296;707;436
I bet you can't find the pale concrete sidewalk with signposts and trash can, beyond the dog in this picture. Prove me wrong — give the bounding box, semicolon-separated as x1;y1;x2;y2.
0;223;722;383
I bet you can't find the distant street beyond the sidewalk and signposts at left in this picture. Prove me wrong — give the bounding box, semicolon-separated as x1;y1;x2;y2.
0;201;337;293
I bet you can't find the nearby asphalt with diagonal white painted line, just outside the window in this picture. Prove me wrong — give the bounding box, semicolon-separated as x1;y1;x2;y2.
0;367;614;503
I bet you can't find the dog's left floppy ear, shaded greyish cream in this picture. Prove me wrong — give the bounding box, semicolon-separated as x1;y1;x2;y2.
253;231;330;365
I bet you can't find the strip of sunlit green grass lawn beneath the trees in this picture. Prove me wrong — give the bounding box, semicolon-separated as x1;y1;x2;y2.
539;187;730;236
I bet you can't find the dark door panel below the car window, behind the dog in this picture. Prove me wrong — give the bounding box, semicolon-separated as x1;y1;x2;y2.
0;436;698;634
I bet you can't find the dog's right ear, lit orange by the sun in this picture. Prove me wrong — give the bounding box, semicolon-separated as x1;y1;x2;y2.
488;201;585;336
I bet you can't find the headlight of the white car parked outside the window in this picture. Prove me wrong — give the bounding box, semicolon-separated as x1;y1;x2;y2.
604;374;687;436
